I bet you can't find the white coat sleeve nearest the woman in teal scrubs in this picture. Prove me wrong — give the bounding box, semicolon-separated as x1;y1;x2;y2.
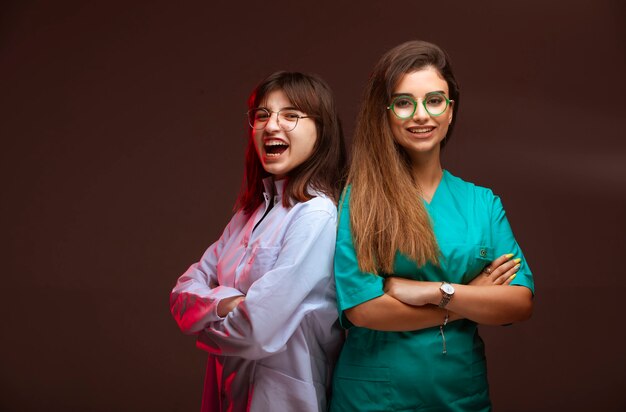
197;210;336;359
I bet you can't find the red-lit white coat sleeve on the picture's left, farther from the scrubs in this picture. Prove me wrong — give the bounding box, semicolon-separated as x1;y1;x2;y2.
170;214;250;334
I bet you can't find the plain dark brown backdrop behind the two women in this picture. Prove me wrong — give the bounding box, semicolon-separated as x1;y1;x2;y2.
0;0;626;411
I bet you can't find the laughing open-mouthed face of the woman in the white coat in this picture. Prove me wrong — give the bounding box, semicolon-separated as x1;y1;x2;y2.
252;90;317;179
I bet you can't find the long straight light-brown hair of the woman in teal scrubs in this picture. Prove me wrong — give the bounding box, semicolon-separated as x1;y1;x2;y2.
348;40;459;273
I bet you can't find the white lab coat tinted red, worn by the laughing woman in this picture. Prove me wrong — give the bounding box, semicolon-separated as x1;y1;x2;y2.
170;178;343;412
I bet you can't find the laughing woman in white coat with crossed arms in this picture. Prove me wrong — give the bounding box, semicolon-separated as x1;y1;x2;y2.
170;72;345;412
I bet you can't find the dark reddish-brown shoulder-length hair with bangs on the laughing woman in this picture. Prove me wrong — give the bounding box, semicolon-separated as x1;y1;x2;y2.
235;71;346;213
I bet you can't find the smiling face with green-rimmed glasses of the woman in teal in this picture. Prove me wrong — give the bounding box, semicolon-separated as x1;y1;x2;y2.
388;67;454;160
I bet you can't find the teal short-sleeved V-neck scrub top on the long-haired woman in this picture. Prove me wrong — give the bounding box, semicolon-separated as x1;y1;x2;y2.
331;171;534;412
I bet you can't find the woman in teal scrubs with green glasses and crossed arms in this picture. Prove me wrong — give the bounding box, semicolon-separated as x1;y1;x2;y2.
331;41;534;412
